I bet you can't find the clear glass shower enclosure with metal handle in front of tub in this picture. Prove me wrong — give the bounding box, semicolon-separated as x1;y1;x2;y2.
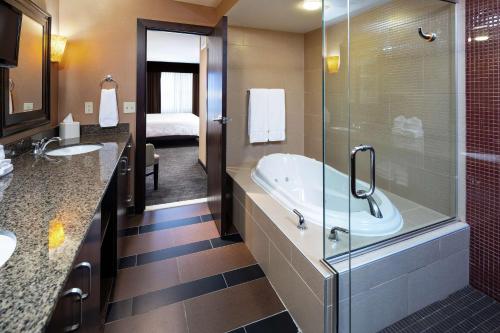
322;0;457;332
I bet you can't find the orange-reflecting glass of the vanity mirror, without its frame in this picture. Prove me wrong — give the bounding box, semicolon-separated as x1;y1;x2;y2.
9;14;43;114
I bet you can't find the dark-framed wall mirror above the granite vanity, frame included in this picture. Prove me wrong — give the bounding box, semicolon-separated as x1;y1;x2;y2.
0;0;50;136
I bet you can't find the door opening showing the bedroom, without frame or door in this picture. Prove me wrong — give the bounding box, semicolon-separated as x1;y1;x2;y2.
145;30;207;208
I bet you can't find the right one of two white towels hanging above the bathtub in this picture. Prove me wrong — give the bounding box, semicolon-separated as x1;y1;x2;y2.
268;89;286;141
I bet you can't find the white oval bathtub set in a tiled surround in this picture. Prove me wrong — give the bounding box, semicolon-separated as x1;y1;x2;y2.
251;154;403;237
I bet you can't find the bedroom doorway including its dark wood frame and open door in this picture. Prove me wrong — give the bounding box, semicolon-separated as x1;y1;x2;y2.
135;18;227;235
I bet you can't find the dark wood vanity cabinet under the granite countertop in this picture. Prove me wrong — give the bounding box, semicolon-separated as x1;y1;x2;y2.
46;137;131;333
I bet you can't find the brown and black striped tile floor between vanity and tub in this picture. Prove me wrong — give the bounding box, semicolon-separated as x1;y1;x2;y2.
105;204;298;333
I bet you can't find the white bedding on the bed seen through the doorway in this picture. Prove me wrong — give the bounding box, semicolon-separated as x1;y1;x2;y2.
146;113;200;138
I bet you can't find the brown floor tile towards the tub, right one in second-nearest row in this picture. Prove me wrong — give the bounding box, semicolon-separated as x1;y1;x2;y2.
177;243;256;283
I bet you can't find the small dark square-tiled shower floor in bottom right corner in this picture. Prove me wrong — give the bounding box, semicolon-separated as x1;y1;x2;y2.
381;287;500;333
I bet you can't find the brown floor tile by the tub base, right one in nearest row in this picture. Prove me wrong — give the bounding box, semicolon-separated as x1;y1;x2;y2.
184;278;285;333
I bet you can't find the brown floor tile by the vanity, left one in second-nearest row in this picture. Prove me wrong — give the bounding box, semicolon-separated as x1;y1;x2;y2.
111;258;180;301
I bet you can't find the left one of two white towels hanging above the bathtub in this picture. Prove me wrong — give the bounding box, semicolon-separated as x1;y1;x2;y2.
248;89;269;143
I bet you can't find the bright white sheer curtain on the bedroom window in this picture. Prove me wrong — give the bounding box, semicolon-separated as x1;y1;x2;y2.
161;72;193;113
